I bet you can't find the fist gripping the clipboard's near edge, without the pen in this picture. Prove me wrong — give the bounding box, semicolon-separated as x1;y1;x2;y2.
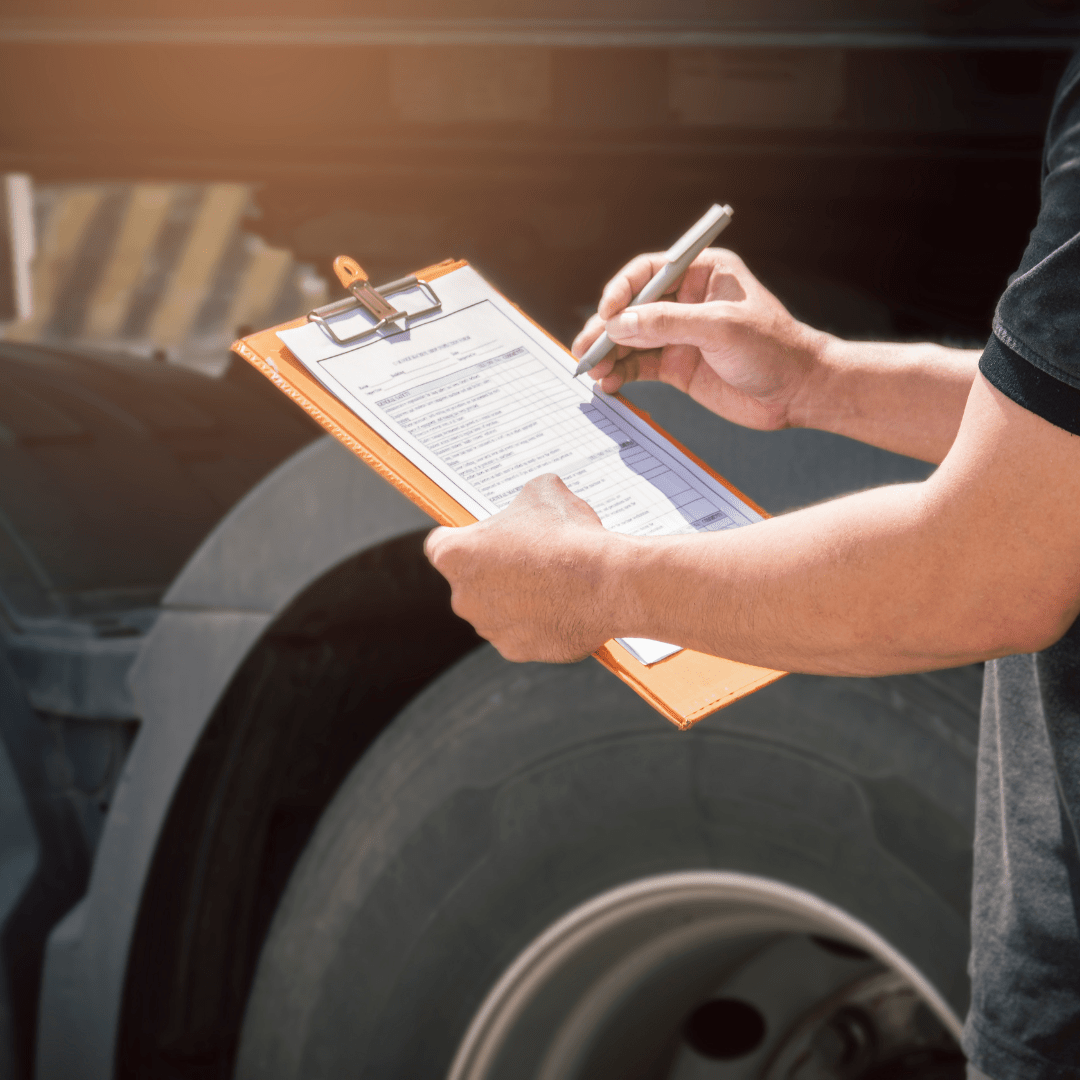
424;474;615;663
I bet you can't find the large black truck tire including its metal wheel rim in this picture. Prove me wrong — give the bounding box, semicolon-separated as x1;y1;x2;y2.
235;647;978;1080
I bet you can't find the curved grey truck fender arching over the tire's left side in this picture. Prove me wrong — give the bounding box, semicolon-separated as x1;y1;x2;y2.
37;437;431;1080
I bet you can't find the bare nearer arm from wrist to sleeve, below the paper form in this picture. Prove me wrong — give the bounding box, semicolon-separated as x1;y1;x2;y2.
599;379;1080;675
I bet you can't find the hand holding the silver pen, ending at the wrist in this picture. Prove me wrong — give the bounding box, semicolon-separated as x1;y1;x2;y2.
573;247;831;431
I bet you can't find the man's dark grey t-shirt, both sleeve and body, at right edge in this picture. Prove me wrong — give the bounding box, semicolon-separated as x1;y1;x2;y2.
963;54;1080;1080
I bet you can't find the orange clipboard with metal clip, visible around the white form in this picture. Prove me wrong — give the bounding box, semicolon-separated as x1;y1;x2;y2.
232;256;786;730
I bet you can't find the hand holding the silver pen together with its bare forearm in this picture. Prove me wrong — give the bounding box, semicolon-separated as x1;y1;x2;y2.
573;247;978;462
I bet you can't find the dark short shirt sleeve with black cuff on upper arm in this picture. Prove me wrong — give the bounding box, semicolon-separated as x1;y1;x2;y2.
978;47;1080;435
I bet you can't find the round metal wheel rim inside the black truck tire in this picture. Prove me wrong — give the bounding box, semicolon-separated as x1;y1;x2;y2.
448;870;961;1080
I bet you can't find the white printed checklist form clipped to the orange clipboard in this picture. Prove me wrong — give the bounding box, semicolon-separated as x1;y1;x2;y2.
279;267;760;663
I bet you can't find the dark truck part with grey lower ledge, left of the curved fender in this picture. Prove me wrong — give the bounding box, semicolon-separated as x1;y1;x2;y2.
0;346;315;719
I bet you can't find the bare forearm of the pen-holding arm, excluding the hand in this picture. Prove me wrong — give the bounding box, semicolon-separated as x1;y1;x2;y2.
789;335;980;463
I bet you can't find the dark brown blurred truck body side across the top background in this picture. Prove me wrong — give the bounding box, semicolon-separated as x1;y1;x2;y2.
0;6;1080;347
